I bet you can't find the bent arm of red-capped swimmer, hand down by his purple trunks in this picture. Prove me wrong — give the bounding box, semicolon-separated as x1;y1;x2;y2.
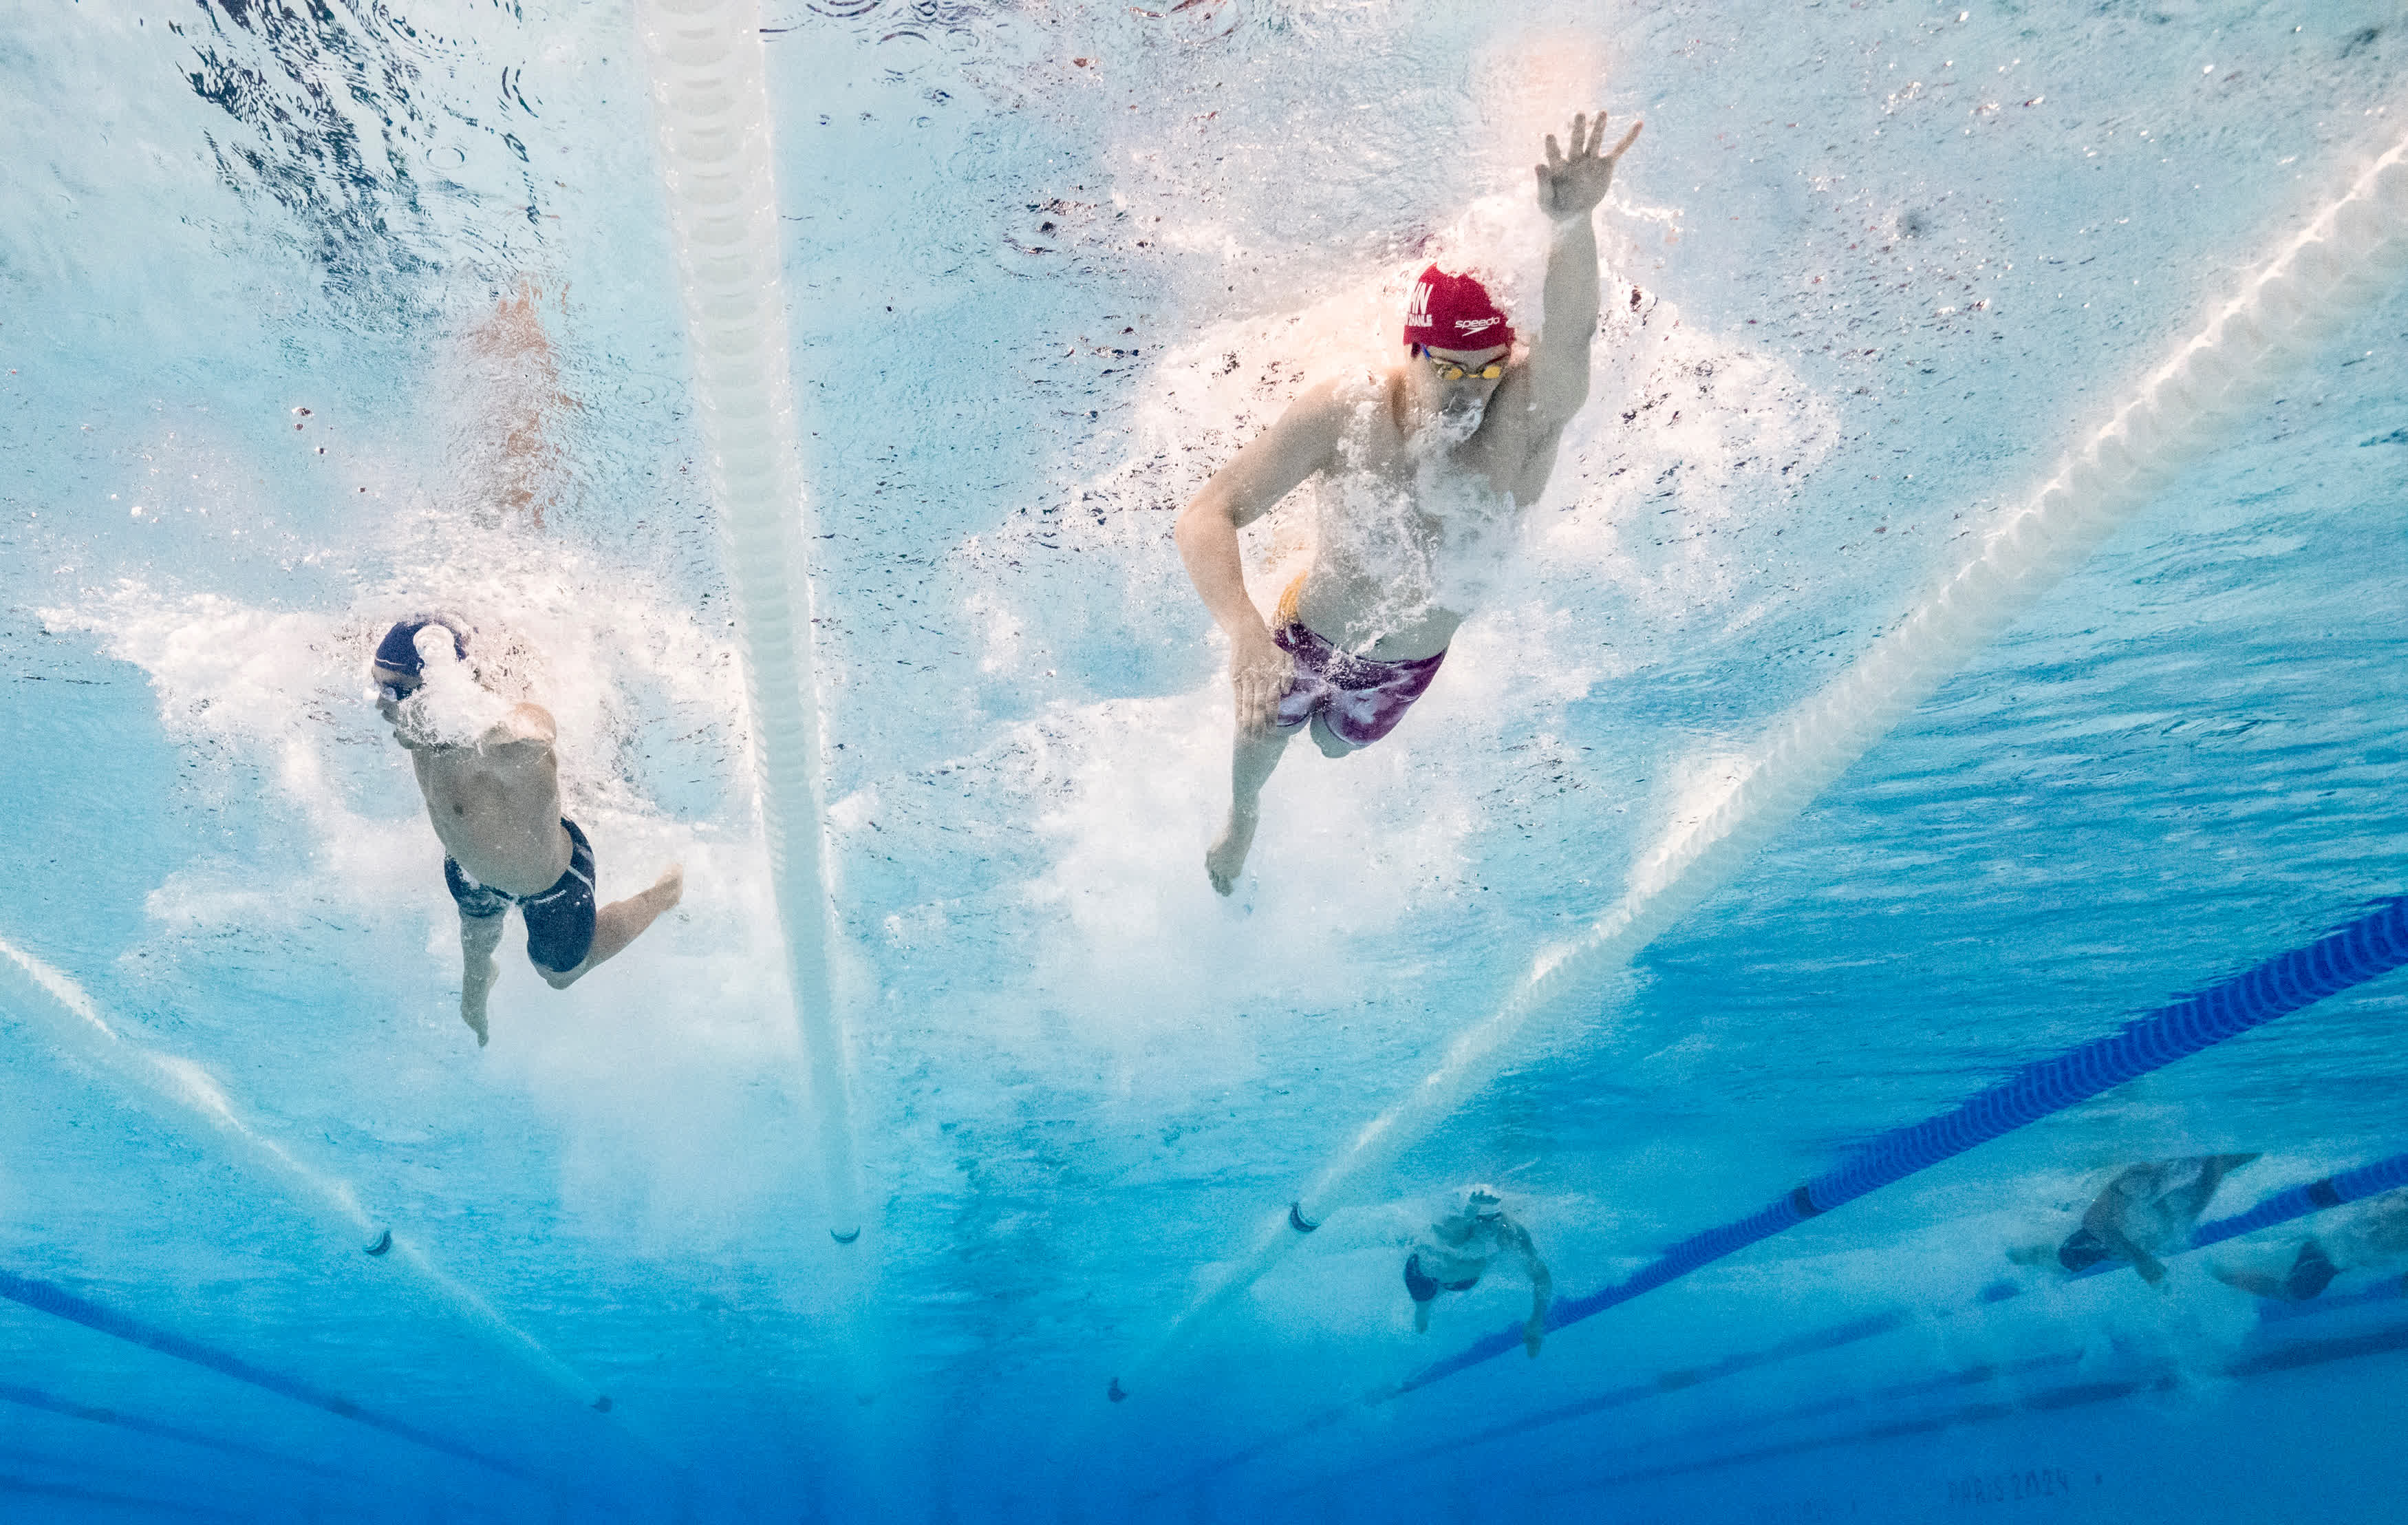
1175;381;1348;730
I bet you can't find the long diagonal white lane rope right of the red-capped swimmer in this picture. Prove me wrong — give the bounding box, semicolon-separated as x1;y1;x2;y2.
1112;140;2408;1395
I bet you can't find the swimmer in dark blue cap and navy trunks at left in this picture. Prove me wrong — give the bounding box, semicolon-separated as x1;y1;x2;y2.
371;615;687;1048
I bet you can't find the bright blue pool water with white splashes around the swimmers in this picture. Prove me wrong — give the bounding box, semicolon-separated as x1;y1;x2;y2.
0;0;2408;1522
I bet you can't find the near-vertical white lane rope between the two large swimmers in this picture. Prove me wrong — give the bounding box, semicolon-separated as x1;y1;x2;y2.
636;0;862;1243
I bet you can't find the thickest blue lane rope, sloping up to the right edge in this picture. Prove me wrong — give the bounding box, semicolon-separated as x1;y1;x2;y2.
1382;899;2408;1397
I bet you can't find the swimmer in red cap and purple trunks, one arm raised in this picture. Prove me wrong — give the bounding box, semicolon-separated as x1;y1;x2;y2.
1178;114;1645;894
